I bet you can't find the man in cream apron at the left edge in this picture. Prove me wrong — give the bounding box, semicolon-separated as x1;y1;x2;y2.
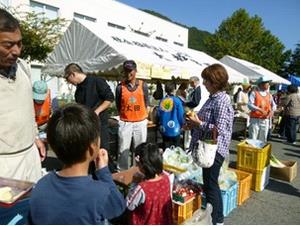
0;9;46;182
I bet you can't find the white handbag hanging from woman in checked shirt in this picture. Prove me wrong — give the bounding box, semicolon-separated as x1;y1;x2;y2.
192;127;218;168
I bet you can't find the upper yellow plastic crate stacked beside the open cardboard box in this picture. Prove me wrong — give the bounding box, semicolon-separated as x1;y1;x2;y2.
237;141;272;173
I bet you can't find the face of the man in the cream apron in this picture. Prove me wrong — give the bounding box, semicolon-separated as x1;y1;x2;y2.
0;29;22;68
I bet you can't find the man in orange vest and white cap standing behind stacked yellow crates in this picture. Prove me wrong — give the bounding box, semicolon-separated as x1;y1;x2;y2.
248;76;276;142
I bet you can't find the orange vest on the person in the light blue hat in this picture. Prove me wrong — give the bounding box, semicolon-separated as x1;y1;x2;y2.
34;90;51;126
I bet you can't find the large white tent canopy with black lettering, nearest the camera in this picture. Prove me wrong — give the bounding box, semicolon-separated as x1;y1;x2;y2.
42;20;248;83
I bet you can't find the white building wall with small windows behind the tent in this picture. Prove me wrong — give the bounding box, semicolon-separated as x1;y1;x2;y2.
6;0;188;47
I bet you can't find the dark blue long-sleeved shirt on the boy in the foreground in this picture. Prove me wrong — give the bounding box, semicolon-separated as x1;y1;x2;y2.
30;167;126;225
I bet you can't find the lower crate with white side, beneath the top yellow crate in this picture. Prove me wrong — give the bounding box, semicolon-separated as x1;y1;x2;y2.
238;165;270;192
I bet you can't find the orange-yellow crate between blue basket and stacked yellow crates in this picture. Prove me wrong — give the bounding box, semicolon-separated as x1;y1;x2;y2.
230;169;252;206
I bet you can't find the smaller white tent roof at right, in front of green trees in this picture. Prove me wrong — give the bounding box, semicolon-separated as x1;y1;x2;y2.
220;55;291;85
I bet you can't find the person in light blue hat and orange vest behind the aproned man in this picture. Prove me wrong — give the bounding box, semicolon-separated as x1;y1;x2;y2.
32;81;51;131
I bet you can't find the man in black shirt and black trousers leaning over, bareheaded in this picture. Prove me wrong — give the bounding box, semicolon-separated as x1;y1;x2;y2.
64;63;114;153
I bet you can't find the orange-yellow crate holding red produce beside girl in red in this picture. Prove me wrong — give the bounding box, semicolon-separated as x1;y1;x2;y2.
172;195;201;224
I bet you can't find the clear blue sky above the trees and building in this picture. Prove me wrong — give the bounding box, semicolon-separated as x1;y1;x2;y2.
117;0;300;50
